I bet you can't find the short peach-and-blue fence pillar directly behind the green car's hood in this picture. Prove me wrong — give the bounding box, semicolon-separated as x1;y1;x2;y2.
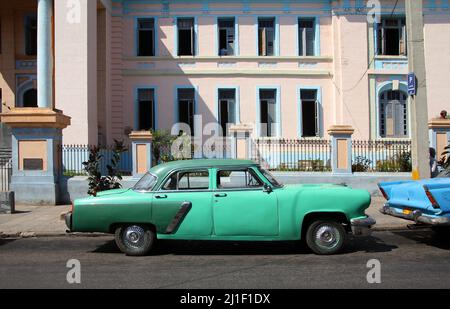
328;125;355;174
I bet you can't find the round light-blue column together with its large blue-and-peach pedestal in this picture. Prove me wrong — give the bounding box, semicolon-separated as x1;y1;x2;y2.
0;0;73;205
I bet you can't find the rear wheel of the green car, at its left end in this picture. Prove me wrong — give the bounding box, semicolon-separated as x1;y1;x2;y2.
115;225;156;256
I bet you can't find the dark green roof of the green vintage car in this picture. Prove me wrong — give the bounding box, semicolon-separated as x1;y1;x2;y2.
150;159;258;177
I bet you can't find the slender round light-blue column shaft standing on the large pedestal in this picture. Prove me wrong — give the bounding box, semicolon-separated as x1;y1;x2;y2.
37;0;53;108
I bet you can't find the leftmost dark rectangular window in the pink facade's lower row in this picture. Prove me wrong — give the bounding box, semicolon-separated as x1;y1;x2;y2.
137;89;155;131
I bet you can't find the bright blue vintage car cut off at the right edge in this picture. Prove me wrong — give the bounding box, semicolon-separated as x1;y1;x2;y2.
378;177;450;230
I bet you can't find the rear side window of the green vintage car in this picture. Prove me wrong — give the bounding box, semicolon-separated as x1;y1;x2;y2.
161;170;209;191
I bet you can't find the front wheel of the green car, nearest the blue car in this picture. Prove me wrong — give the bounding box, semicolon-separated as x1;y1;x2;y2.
306;220;347;255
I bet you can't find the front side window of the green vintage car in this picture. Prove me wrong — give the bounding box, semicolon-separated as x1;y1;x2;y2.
217;169;264;189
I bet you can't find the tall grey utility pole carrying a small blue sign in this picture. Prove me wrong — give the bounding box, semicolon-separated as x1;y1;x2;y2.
405;0;431;180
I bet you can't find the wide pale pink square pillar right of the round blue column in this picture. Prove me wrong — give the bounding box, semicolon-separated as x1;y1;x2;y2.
55;0;98;145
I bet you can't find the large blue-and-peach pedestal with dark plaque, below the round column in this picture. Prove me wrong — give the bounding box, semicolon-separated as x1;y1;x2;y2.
0;108;70;205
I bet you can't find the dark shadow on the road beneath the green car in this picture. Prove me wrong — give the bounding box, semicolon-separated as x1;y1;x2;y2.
92;237;397;256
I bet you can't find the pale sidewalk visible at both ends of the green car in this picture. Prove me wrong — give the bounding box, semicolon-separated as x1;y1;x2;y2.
0;197;412;237
